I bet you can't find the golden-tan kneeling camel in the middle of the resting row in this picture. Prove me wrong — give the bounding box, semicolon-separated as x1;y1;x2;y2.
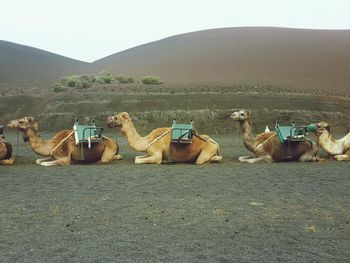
107;112;222;164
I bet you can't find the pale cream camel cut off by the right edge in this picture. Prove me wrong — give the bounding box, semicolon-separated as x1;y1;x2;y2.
316;122;350;161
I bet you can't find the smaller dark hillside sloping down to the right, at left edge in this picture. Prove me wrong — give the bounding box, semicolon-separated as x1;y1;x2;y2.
0;40;90;88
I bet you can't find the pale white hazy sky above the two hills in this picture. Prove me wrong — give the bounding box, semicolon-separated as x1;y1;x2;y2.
0;0;350;62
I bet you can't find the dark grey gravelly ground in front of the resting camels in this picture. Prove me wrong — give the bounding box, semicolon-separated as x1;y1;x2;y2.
0;134;350;262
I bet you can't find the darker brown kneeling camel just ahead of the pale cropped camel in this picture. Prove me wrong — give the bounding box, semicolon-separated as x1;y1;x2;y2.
231;110;320;163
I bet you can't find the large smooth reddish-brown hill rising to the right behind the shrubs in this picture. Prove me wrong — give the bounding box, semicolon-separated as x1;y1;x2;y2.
93;28;350;94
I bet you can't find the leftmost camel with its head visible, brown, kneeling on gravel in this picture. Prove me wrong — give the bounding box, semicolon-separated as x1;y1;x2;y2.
7;117;121;166
